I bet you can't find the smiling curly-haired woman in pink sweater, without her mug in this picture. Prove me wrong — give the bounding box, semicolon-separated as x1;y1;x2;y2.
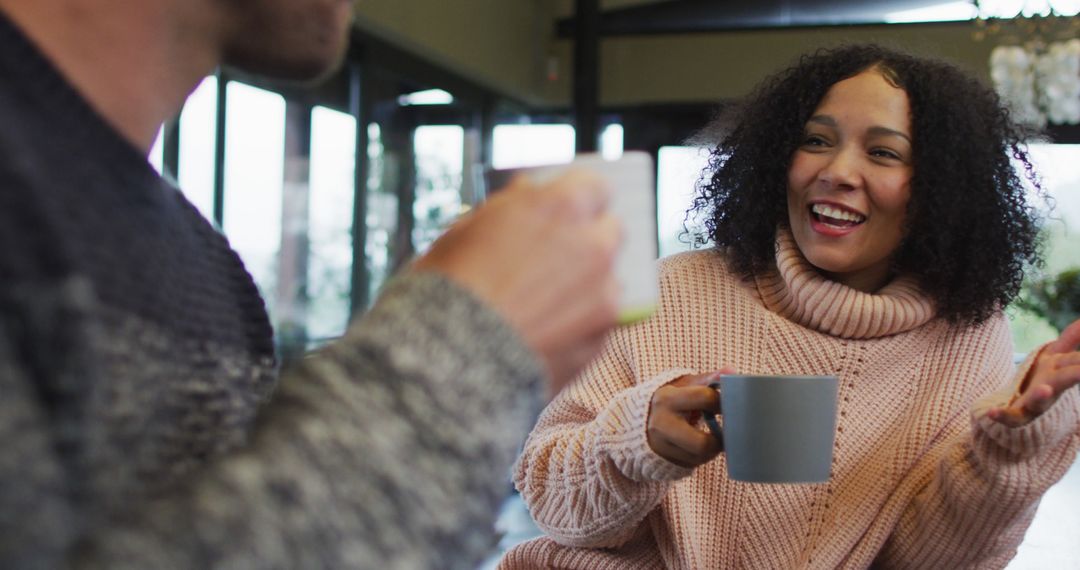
502;45;1080;569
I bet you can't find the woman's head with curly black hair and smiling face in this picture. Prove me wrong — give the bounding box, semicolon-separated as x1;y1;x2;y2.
694;46;1041;323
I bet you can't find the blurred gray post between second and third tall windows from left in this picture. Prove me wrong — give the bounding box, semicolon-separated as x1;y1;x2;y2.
274;99;311;364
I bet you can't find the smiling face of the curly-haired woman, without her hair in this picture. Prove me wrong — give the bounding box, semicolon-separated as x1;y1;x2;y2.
787;69;913;293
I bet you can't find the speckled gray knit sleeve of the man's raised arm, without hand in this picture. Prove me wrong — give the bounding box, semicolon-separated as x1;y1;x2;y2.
0;275;542;570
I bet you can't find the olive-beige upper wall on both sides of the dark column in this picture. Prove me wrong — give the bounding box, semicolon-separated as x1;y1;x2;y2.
356;0;994;108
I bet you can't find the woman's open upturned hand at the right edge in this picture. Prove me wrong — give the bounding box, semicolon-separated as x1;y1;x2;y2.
987;320;1080;428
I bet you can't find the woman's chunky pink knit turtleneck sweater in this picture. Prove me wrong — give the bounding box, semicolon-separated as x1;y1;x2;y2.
500;235;1080;570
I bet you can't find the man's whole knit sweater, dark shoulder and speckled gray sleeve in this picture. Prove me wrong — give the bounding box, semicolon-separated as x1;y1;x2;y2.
0;9;542;569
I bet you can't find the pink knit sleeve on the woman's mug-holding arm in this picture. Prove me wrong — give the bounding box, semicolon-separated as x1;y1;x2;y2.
514;330;692;547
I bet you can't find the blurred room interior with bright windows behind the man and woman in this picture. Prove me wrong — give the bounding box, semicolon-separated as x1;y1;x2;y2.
150;0;1080;569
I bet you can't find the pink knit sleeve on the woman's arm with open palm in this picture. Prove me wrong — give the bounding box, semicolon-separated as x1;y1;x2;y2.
877;318;1080;569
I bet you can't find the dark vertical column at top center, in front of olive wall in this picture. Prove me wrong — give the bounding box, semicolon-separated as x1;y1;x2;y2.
573;0;600;152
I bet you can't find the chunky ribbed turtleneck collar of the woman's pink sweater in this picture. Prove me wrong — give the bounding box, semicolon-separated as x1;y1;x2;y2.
755;229;934;339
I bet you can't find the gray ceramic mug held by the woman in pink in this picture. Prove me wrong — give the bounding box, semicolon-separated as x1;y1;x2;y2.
704;375;837;483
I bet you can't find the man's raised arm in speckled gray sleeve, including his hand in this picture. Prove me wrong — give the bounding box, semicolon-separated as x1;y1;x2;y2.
0;171;618;569
